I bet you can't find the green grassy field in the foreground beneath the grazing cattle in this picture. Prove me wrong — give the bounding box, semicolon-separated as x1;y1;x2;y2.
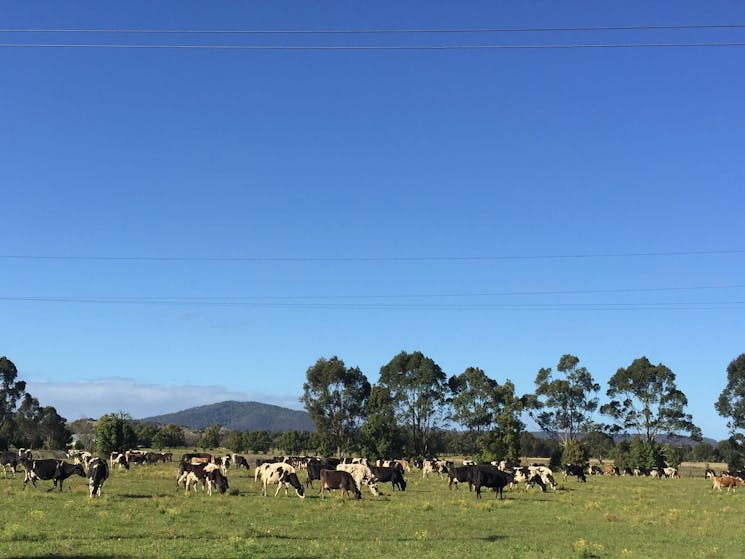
0;458;745;559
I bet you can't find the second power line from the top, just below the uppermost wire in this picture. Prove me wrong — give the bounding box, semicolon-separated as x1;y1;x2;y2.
0;42;745;51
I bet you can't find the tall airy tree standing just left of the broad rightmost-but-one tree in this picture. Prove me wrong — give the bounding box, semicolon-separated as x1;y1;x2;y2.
530;354;600;444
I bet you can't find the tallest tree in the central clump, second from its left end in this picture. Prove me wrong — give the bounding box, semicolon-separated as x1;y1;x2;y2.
379;351;448;456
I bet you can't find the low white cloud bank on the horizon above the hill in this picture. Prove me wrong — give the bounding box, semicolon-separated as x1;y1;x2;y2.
26;378;300;421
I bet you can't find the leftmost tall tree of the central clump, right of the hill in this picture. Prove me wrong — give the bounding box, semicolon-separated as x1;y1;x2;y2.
300;356;370;456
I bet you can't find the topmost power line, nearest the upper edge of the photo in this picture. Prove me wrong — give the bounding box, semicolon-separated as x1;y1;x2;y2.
0;23;745;35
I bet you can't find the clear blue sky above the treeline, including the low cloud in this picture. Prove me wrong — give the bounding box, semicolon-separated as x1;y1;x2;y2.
0;1;745;438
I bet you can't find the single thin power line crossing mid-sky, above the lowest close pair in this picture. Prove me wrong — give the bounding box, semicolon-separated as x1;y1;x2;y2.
0;249;745;263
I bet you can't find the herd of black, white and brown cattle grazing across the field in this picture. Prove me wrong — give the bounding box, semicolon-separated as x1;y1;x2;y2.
0;449;745;499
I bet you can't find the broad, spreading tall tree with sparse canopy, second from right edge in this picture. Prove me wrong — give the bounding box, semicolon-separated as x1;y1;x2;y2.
600;357;701;443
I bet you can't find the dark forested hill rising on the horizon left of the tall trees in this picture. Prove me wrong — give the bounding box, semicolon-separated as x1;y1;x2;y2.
141;401;315;433
